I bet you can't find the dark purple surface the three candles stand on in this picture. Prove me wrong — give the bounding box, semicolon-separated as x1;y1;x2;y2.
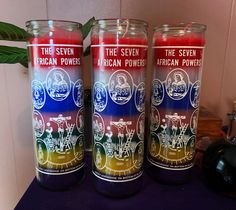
15;155;236;210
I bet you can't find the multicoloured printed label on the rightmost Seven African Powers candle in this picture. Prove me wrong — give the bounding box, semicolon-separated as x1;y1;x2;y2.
148;46;203;170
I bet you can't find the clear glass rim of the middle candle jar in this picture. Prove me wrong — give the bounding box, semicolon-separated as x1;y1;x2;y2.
93;18;148;27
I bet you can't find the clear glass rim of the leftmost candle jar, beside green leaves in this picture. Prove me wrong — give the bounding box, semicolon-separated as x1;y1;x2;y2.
25;19;82;28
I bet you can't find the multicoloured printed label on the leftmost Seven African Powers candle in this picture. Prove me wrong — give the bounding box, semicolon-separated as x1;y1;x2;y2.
28;44;84;175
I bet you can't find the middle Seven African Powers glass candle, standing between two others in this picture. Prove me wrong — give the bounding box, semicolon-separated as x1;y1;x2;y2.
91;19;148;197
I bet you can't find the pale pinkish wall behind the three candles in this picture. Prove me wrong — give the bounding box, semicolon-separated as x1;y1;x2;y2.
0;0;236;210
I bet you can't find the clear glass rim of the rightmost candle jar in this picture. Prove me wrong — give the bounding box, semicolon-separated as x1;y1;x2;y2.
154;22;207;32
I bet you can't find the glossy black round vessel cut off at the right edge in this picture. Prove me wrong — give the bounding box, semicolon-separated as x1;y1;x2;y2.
202;139;236;197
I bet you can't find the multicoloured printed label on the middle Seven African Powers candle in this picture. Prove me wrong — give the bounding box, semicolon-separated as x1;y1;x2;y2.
92;45;147;182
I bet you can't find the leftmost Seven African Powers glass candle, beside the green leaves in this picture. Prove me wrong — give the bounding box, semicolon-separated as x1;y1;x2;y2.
26;20;84;190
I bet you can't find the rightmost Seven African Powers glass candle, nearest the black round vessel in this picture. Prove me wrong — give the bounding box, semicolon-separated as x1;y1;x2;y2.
147;23;206;184
